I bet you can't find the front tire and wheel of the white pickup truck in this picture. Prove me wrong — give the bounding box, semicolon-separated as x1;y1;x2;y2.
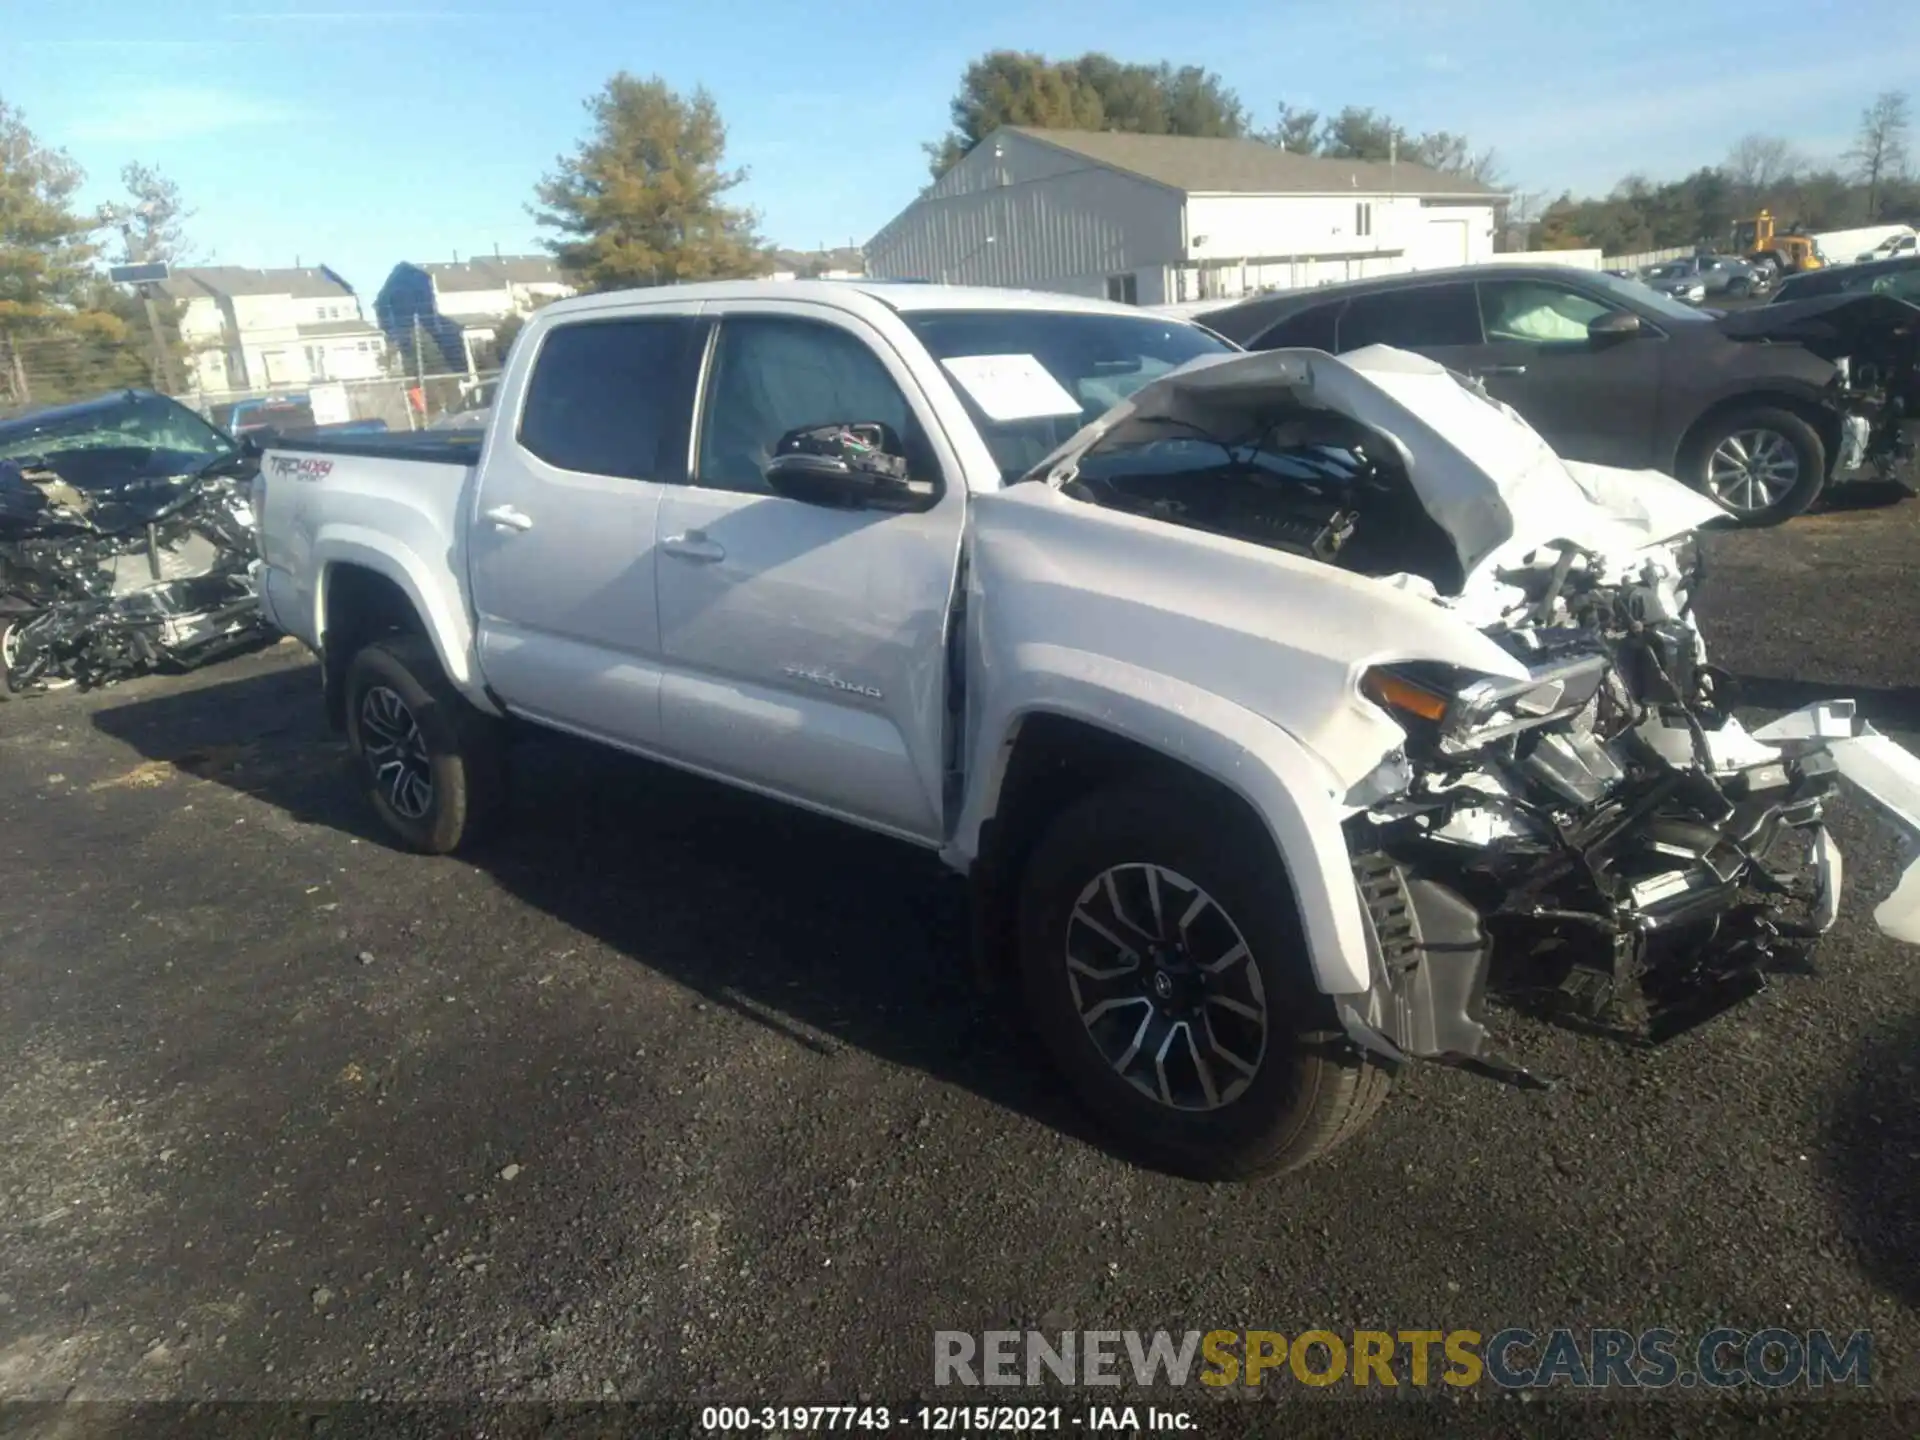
1020;780;1388;1179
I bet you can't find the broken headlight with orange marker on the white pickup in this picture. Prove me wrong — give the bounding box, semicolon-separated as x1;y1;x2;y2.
1359;653;1611;755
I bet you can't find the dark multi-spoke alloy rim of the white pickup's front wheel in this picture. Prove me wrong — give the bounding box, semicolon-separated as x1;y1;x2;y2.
1066;864;1267;1110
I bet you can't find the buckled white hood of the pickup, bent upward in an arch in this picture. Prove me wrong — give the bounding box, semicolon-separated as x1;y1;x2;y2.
1023;347;1728;588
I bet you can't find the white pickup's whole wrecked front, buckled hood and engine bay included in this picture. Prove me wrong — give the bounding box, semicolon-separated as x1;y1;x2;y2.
1035;343;1920;1085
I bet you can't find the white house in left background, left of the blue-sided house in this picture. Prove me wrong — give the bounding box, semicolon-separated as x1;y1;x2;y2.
161;265;386;392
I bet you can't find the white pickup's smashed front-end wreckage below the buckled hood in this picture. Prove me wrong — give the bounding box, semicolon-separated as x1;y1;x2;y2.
1346;541;1920;1081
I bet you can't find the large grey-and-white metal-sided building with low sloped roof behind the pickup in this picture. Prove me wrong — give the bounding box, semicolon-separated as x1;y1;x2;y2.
866;125;1501;305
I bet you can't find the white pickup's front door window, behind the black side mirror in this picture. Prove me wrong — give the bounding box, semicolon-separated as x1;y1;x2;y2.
695;315;935;495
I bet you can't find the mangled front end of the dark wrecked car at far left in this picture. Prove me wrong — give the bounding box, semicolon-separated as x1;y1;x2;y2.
0;451;267;693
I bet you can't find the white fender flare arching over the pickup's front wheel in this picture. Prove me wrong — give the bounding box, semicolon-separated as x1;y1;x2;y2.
947;643;1371;995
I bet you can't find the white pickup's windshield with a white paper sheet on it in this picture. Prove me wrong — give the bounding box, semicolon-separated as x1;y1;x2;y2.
902;309;1235;482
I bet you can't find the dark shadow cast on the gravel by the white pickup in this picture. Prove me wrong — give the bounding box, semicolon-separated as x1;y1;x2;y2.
92;666;1108;1148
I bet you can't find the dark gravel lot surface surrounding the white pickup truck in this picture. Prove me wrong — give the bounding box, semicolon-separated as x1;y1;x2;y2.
0;481;1920;1434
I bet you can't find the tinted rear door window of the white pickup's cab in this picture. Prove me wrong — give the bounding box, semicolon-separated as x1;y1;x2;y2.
520;315;697;482
